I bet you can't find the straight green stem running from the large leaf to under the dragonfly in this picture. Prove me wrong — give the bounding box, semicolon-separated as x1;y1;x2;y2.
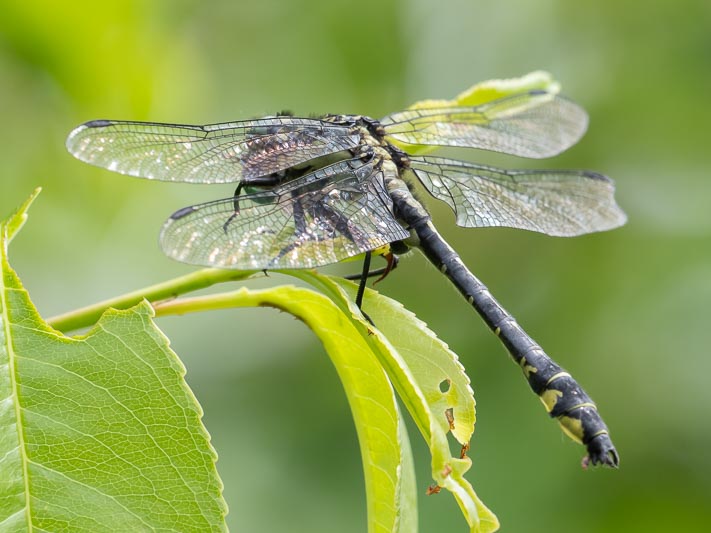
47;268;255;332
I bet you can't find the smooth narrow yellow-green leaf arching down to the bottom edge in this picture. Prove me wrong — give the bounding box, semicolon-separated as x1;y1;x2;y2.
156;285;417;533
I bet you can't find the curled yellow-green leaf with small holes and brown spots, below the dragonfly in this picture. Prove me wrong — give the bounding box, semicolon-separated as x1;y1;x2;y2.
284;271;499;533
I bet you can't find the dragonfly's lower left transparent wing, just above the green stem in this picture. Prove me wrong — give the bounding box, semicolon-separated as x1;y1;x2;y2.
160;159;409;270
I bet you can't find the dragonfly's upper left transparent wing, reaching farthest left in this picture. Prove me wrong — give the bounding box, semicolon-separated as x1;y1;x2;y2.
66;117;360;183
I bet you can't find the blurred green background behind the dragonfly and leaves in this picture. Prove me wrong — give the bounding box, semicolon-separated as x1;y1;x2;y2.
0;0;711;533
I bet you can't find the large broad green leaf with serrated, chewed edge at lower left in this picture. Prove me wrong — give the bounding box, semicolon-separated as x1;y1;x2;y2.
0;191;227;532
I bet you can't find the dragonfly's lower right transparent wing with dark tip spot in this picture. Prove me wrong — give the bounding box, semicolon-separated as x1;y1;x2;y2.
411;157;626;237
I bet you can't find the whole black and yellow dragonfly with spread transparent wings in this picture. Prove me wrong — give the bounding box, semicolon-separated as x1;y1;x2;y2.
66;84;626;467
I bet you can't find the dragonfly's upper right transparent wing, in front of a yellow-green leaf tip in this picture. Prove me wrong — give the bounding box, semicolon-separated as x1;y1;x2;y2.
380;90;588;158
